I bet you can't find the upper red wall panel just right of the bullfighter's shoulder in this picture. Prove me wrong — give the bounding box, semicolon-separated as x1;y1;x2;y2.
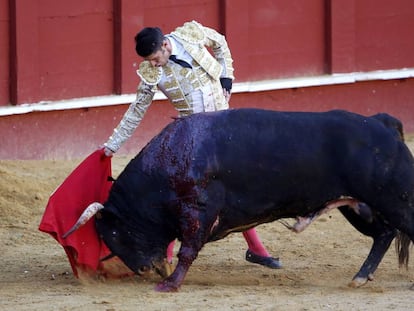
226;0;325;81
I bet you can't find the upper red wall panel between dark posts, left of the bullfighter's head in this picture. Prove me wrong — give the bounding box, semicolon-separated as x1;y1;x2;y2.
10;0;114;104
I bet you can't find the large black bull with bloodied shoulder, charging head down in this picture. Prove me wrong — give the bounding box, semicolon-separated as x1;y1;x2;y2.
64;109;414;291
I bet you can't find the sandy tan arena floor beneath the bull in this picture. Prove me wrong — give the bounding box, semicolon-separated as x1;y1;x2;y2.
0;137;414;311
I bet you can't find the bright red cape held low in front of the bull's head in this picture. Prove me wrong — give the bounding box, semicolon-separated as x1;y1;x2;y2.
39;150;131;277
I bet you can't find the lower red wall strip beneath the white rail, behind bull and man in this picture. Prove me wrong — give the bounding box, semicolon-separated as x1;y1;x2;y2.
0;79;414;159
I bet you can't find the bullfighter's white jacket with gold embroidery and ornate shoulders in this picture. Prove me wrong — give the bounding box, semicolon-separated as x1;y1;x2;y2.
104;21;234;152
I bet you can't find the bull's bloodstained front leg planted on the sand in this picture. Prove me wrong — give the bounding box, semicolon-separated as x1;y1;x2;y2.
155;205;208;292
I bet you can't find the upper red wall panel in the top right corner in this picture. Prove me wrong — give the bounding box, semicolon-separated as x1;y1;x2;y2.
354;0;414;71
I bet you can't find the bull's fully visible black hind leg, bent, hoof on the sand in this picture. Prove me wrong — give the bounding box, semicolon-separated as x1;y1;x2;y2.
339;203;397;287
